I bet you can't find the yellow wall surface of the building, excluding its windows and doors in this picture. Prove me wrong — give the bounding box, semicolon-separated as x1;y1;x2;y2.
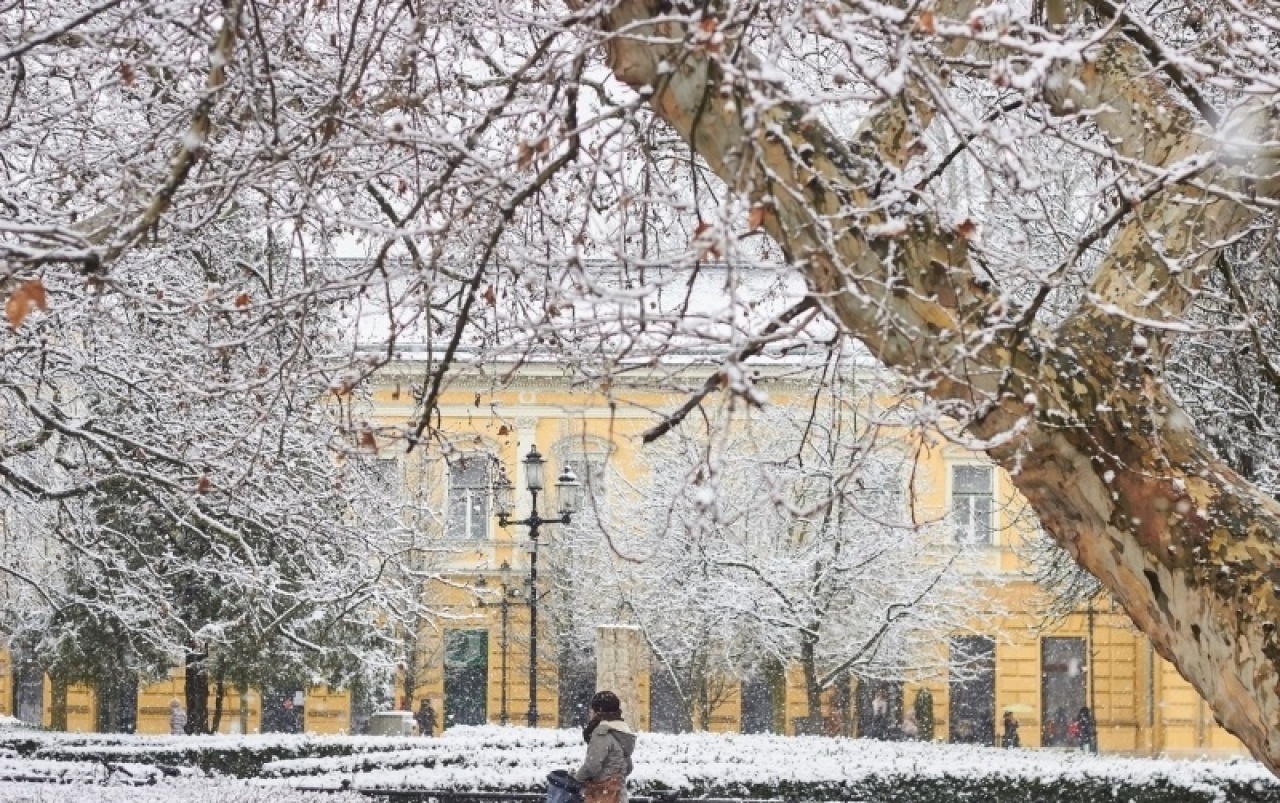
0;362;1240;754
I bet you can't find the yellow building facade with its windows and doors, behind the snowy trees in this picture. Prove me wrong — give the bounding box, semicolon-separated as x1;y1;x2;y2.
0;360;1242;756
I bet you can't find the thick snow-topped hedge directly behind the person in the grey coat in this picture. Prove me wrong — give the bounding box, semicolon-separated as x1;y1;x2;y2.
272;726;1280;803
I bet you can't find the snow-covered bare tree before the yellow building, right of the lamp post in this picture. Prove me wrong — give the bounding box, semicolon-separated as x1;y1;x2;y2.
586;384;987;724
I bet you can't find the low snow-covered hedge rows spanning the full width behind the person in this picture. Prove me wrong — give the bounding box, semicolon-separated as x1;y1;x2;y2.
0;727;1280;803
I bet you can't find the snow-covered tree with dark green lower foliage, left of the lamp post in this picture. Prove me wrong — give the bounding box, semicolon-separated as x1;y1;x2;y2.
0;235;421;733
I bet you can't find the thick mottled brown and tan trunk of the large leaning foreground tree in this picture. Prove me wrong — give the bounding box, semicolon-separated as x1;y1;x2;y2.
591;0;1280;771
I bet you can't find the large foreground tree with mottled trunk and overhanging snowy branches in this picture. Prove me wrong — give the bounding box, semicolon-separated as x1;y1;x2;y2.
0;0;1280;768
